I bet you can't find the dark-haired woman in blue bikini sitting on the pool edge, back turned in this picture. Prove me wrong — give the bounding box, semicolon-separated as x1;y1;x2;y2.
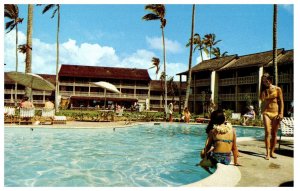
199;110;239;171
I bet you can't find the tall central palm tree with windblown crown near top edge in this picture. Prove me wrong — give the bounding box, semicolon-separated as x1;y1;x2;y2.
142;4;167;115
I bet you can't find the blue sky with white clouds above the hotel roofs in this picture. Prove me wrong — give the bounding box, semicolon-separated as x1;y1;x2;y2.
4;4;294;79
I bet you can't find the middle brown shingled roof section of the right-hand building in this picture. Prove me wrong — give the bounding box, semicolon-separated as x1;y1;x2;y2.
221;49;283;70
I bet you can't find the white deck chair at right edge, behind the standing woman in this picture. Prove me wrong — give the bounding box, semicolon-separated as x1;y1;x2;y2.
278;117;294;150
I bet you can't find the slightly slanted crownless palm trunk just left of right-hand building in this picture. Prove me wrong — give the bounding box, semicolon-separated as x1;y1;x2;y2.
184;4;195;108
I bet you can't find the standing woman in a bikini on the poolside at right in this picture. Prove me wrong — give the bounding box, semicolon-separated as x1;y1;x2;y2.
260;73;284;160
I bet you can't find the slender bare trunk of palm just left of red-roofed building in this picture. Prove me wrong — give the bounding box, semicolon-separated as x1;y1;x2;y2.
55;6;60;112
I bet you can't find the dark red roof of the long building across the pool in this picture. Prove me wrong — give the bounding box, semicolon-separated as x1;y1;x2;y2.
59;64;151;81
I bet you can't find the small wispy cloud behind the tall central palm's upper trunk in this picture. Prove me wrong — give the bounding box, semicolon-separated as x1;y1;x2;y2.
146;36;183;53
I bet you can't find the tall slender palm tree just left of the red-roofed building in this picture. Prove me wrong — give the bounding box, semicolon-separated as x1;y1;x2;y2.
43;4;60;112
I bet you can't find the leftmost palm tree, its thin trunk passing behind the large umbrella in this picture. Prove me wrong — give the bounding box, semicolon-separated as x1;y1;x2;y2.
4;4;23;106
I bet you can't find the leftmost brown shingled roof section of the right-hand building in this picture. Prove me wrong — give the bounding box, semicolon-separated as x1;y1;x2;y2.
177;55;237;75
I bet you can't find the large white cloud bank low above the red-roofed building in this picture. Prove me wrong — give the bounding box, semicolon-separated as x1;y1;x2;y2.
4;32;187;80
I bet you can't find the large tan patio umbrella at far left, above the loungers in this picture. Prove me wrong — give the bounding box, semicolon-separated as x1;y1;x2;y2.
7;72;55;91
